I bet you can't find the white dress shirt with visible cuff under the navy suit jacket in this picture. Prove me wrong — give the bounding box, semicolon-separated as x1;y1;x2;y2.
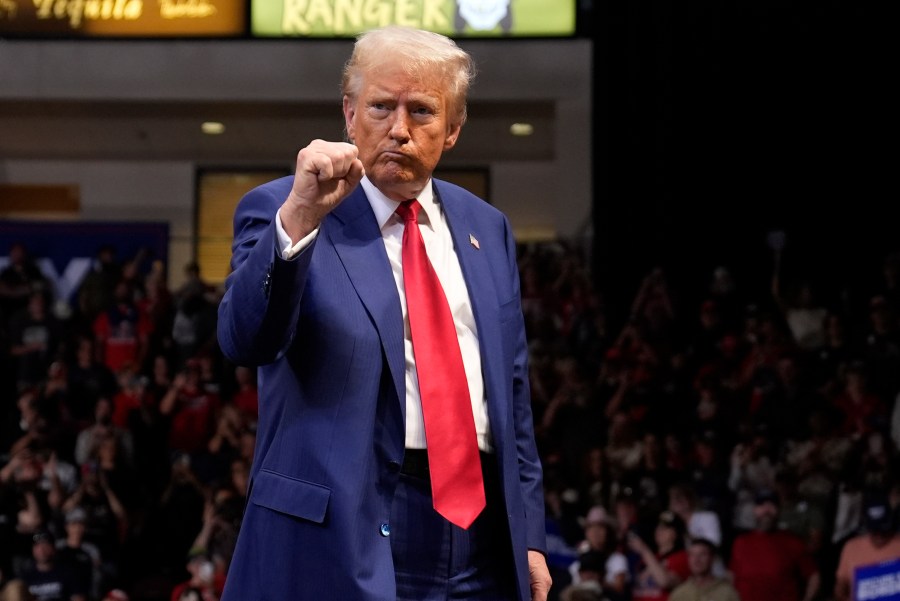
275;177;493;452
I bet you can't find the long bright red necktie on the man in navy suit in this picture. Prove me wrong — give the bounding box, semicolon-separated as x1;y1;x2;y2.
397;200;485;528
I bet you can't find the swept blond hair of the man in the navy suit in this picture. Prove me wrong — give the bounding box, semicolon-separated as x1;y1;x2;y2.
341;25;475;125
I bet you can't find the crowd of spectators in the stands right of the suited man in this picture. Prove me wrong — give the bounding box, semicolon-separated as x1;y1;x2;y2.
520;245;900;601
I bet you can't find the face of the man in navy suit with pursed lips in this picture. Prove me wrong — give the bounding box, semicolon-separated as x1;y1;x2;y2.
344;69;461;201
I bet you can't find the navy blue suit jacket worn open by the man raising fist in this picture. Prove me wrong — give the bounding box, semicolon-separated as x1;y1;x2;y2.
218;177;545;601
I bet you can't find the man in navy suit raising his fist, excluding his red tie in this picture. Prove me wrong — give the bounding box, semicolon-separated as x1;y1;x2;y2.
218;27;550;601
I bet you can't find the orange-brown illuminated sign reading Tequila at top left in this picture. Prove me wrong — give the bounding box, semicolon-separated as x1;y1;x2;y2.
0;0;246;37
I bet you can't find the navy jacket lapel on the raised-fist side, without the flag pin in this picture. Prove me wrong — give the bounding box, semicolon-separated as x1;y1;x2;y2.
327;187;406;408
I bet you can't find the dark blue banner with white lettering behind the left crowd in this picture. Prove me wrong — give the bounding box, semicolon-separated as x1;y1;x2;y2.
0;221;169;304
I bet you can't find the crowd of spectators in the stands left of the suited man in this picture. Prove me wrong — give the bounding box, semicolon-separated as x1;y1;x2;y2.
0;245;243;601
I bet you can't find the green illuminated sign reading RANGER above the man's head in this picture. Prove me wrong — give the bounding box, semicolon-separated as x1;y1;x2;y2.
251;0;575;37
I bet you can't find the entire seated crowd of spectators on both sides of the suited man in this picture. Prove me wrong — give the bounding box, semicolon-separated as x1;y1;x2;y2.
0;236;900;601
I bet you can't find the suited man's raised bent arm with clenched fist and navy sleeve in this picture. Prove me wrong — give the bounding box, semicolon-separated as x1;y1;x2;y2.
218;140;363;366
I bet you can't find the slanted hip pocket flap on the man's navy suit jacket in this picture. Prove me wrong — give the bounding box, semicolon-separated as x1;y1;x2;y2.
250;470;331;524
